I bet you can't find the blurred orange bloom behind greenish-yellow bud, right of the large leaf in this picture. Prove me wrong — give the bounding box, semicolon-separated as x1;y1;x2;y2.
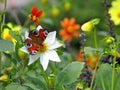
86;54;98;68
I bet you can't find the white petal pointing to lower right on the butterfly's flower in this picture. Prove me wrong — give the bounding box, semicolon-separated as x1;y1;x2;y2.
47;50;61;62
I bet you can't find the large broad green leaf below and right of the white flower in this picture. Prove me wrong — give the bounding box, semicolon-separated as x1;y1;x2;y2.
55;62;84;90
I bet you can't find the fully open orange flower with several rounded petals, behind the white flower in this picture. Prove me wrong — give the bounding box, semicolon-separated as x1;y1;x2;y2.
59;18;80;42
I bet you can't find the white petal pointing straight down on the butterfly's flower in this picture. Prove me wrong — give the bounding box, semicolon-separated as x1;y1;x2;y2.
40;53;49;71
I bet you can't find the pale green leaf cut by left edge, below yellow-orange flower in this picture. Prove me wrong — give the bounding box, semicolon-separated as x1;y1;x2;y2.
0;39;14;52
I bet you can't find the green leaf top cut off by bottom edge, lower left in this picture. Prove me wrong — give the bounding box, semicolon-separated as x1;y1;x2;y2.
5;83;27;90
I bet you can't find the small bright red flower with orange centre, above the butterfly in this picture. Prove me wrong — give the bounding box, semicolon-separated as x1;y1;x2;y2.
30;7;43;25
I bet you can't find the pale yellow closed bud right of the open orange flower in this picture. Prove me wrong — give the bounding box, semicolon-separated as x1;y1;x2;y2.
81;22;94;32
